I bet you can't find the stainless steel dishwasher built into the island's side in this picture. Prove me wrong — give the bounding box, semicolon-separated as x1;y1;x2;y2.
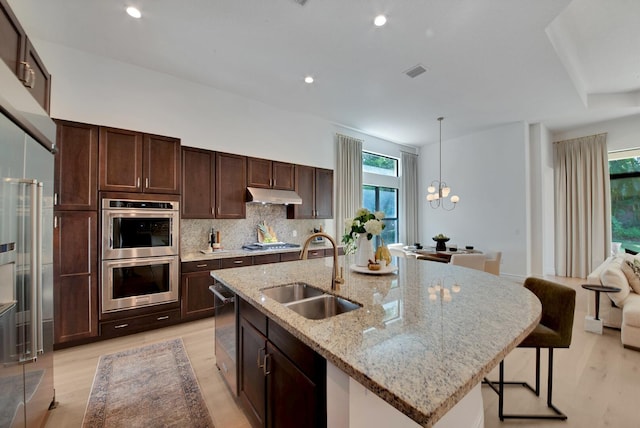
209;282;238;396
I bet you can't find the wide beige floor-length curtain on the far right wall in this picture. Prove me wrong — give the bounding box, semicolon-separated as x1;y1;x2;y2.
553;134;611;278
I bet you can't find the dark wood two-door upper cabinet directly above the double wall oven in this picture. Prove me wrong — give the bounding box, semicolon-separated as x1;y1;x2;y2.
99;127;180;194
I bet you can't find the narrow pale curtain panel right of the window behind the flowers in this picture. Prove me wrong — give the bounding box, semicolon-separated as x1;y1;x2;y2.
400;152;420;245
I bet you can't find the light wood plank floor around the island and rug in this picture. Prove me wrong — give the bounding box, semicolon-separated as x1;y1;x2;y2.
46;277;640;428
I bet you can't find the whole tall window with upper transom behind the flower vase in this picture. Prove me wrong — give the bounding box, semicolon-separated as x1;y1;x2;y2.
362;151;399;247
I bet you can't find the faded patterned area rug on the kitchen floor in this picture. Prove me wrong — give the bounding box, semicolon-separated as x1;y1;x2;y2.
82;339;213;428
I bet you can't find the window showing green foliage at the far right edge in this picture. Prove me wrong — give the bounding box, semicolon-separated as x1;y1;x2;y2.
609;157;640;251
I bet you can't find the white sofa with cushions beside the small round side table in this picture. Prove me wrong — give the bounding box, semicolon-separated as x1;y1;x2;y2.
587;254;640;351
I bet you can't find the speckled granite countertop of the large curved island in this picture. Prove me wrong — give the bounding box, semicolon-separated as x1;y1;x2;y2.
211;256;541;427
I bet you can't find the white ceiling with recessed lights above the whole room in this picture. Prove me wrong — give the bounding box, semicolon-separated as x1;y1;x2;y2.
9;0;640;145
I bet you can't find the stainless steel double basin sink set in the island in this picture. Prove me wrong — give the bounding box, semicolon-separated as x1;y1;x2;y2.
262;282;362;320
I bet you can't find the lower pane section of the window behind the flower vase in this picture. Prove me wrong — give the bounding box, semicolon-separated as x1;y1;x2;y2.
362;185;398;248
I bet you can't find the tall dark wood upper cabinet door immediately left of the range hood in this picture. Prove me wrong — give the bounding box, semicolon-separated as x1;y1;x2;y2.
215;153;247;219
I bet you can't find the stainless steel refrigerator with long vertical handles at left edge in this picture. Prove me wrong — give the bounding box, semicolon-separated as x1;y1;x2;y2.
0;64;55;428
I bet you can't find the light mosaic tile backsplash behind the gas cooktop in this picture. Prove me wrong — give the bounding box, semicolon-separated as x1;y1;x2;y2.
180;204;330;254
